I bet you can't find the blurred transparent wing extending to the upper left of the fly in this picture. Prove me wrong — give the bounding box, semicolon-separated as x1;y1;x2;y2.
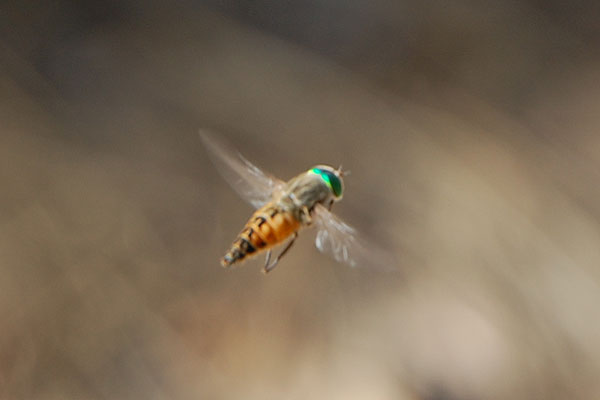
200;130;285;208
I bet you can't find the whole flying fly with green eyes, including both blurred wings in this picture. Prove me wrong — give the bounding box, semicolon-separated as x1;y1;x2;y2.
200;131;393;272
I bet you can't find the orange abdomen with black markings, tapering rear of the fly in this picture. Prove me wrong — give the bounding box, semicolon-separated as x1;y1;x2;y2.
221;204;300;267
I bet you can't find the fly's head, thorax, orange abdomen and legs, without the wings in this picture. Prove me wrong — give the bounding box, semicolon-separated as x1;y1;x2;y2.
221;165;343;272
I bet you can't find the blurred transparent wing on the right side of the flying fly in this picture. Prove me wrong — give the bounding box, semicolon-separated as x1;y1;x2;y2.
313;204;397;270
